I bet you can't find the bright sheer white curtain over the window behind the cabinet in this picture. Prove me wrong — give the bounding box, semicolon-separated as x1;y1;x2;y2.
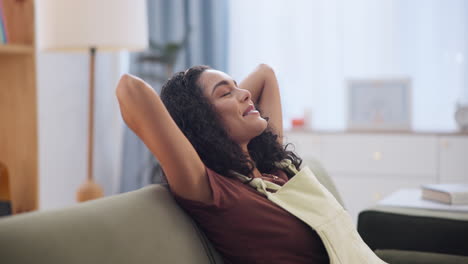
228;0;468;131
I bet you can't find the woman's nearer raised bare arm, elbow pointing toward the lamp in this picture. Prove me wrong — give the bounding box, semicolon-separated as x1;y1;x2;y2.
115;74;212;201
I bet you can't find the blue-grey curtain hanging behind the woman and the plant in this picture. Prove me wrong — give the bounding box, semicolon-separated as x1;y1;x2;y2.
120;0;229;192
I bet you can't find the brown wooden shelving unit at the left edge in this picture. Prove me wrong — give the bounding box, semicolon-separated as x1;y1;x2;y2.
0;0;38;214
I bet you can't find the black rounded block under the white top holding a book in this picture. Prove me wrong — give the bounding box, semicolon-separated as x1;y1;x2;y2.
358;206;468;256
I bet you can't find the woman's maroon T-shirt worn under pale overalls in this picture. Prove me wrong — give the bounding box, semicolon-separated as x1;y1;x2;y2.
173;168;329;264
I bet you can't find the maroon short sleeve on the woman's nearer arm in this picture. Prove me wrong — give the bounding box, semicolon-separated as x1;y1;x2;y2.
172;167;242;212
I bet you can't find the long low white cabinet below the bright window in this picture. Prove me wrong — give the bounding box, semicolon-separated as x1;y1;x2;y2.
285;132;468;222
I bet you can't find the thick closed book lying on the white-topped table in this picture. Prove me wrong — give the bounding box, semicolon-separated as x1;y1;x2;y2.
422;184;468;205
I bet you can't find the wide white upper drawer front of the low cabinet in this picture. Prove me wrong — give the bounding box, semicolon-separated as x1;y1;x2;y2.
321;134;437;177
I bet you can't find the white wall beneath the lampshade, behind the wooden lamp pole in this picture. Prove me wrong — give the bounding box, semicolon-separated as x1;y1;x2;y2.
37;52;126;209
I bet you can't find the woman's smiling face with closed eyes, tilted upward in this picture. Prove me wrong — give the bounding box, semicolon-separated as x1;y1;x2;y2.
199;69;268;145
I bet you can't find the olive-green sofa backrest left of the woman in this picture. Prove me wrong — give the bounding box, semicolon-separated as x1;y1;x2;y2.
0;185;222;264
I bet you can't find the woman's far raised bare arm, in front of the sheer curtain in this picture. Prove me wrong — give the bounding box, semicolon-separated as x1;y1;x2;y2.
239;64;283;144
